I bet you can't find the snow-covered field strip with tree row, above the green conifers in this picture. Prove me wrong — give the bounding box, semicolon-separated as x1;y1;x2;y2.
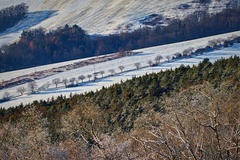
0;31;240;108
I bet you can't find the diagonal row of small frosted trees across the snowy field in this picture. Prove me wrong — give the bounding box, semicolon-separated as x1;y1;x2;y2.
2;34;239;101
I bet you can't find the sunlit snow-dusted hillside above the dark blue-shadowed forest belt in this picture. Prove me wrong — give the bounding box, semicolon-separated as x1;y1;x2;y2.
0;0;239;45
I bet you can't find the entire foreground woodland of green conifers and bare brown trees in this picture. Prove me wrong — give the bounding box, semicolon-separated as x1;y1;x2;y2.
0;57;240;160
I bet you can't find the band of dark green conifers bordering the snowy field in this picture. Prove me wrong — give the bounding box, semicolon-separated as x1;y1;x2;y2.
0;56;240;142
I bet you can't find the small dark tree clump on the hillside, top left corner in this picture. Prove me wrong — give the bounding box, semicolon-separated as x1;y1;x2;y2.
0;3;28;32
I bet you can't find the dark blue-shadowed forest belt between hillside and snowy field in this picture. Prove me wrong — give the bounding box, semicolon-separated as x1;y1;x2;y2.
0;9;240;72
